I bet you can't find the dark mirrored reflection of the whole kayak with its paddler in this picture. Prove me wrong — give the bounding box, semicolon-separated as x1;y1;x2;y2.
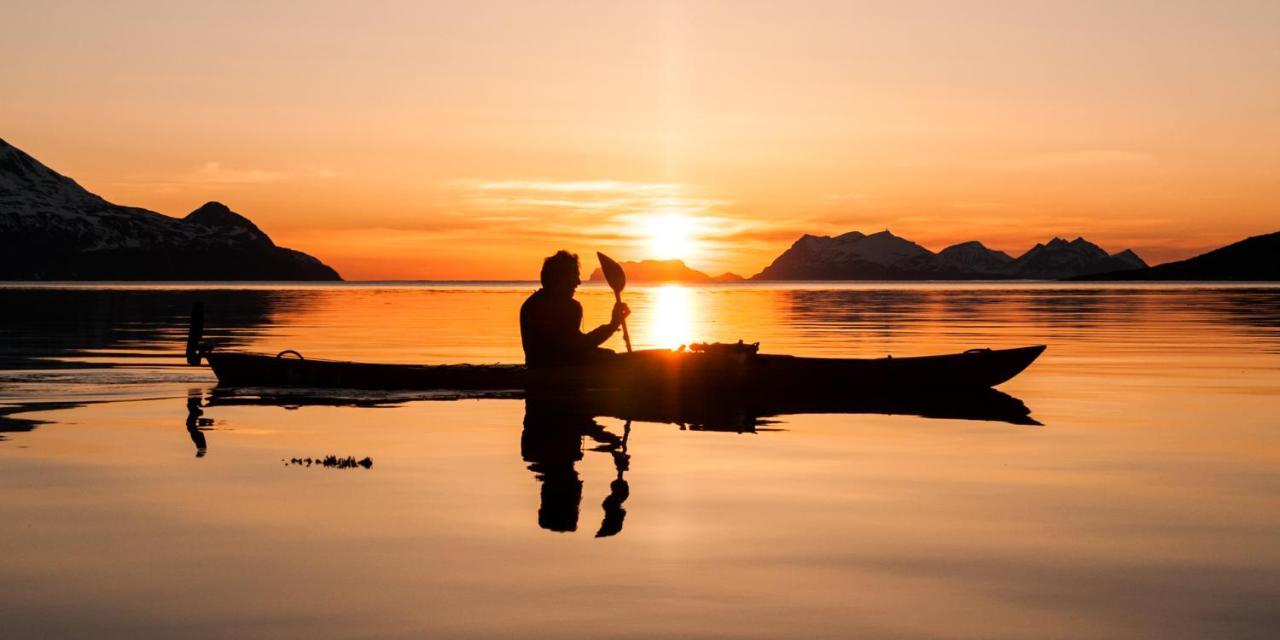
199;387;1039;538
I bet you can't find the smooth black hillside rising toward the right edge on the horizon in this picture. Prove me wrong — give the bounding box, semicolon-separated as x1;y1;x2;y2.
1082;232;1280;280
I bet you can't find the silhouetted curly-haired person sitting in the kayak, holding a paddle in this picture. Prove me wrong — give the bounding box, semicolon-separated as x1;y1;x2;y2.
520;251;631;367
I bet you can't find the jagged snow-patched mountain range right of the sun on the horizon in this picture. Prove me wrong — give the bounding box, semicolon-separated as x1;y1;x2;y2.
753;230;1146;280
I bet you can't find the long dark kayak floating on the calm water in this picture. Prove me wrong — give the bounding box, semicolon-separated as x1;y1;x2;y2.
202;344;1044;394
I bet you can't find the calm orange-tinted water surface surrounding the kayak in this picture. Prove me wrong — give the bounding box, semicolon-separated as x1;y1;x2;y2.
0;284;1280;639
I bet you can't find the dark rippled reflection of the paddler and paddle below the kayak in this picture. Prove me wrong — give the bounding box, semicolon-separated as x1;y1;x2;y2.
520;398;631;538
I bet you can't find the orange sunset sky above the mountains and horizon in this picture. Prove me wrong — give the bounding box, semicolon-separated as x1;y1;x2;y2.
0;1;1280;279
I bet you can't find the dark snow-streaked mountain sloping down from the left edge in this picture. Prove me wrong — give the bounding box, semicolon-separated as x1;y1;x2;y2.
0;140;342;280
